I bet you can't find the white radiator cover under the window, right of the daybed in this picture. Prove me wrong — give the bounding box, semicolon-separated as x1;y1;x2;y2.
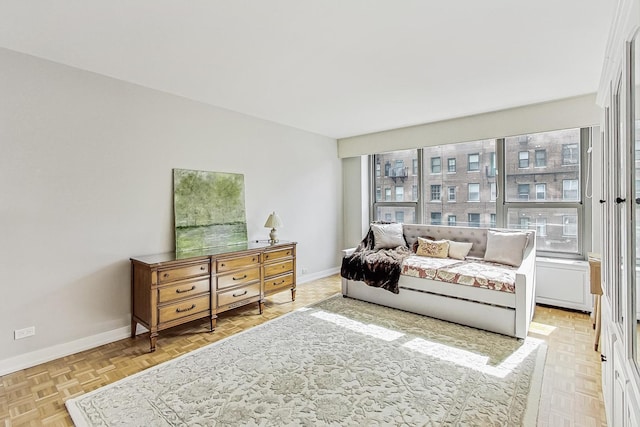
536;257;593;312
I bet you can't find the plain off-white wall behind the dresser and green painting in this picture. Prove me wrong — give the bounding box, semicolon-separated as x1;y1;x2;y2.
0;49;342;370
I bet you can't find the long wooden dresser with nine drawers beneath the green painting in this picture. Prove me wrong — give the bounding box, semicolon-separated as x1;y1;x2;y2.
131;241;296;351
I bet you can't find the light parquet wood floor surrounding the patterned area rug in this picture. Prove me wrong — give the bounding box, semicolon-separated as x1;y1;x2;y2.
0;276;606;427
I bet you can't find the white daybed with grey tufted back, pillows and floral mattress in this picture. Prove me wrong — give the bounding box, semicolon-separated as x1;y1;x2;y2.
341;224;536;338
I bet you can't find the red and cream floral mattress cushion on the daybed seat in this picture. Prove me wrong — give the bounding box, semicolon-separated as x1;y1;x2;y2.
402;256;517;293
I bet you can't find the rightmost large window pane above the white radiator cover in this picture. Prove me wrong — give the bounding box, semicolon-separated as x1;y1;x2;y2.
499;129;589;258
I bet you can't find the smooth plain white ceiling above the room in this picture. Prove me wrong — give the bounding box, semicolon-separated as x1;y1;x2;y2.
0;0;616;138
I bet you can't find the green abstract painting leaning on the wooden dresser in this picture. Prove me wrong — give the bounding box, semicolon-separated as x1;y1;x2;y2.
173;169;247;252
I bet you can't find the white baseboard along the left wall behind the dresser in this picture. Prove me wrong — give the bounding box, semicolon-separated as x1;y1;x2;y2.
0;267;340;376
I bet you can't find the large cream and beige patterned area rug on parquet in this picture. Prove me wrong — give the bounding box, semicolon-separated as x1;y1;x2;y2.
66;296;546;426
